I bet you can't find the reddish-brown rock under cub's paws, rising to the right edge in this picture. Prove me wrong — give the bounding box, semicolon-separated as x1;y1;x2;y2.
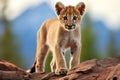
27;56;120;80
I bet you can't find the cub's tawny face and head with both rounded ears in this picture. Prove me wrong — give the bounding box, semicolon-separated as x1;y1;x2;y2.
55;2;85;31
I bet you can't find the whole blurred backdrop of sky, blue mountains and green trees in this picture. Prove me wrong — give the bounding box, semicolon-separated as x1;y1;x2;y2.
0;0;120;72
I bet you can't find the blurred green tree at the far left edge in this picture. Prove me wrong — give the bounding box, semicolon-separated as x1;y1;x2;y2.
0;0;25;68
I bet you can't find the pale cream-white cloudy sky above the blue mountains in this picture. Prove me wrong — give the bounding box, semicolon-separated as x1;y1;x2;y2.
0;0;120;30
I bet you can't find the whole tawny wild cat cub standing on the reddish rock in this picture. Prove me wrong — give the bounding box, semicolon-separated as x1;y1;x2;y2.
30;2;85;75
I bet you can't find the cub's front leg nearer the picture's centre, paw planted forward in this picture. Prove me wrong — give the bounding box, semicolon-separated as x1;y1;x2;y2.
53;45;67;75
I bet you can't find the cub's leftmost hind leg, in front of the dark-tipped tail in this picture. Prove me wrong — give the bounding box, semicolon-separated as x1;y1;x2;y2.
35;27;49;72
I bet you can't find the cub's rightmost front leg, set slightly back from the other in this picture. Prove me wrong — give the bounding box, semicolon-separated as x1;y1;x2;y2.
69;44;81;69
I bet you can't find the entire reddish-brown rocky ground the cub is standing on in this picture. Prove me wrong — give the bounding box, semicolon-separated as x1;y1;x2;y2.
0;56;120;80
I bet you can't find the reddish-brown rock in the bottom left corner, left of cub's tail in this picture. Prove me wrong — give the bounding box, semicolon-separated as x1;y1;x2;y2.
0;59;29;80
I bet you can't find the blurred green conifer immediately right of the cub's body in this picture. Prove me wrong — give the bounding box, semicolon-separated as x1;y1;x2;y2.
81;14;99;62
